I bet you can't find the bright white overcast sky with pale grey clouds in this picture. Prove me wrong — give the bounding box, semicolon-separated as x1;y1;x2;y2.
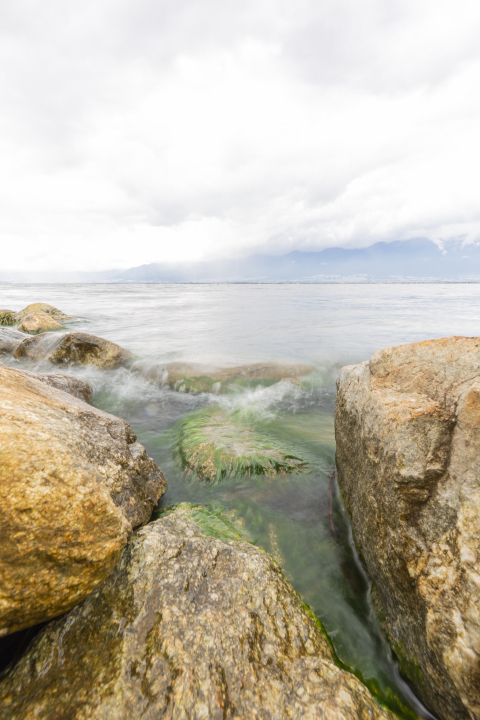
0;0;480;271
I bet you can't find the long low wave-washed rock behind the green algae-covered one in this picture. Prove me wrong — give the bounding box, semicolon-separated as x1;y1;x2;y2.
145;362;314;393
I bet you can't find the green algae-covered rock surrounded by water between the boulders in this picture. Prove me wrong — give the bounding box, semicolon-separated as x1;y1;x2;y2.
177;408;307;482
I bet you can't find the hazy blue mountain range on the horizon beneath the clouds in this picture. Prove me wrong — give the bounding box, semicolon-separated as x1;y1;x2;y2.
0;238;480;283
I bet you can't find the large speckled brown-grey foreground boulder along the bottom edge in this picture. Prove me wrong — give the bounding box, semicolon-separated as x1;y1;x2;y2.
0;510;393;720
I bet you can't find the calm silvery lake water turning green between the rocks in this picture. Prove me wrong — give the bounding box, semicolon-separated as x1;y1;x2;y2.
0;284;480;718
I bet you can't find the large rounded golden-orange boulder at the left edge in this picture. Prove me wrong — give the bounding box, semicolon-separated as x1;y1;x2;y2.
0;366;166;635
